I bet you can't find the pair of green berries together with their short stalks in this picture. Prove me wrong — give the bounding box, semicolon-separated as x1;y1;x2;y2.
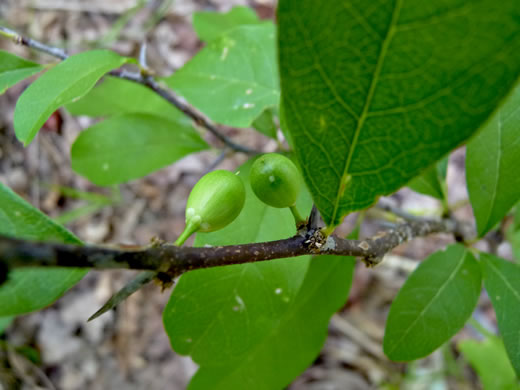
175;153;303;245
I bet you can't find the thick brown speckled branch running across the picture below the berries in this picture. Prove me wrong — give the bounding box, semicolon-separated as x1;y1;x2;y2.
0;215;476;277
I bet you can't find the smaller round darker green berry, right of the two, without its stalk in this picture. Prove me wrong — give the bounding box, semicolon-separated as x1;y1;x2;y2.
250;153;302;208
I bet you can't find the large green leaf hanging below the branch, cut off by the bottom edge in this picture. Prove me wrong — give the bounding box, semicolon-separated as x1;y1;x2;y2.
189;256;355;390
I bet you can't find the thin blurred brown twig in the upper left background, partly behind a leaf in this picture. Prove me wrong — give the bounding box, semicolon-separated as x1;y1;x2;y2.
0;26;258;154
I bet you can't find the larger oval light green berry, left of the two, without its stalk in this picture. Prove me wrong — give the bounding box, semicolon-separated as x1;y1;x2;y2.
186;170;246;232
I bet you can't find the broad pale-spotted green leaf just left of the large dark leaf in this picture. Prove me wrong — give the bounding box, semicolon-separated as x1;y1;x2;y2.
166;23;280;127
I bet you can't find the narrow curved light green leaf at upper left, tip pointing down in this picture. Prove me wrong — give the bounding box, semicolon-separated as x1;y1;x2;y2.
14;50;128;145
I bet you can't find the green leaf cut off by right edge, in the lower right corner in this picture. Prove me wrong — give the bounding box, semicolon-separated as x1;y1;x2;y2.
480;253;520;377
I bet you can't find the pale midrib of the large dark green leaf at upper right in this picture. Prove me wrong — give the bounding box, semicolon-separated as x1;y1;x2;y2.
330;0;403;225
